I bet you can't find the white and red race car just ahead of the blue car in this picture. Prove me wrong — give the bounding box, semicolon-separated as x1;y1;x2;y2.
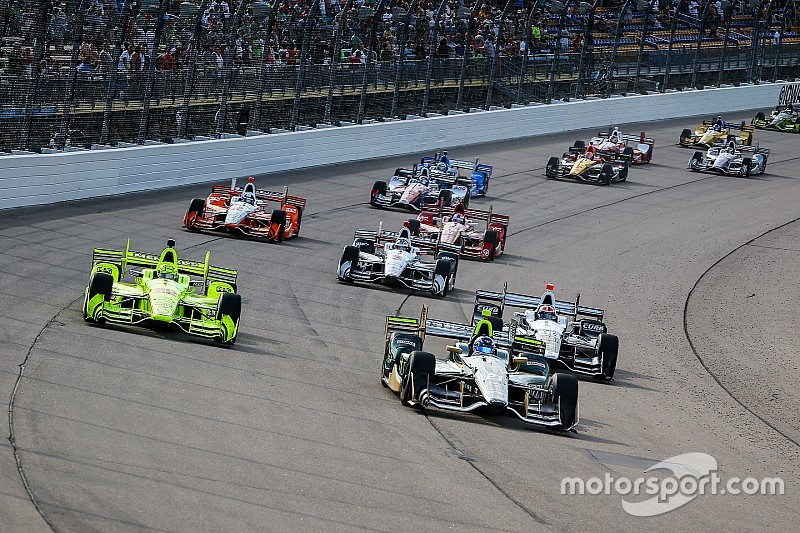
369;166;472;211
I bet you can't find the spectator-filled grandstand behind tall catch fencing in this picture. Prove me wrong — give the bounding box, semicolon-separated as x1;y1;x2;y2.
0;0;800;152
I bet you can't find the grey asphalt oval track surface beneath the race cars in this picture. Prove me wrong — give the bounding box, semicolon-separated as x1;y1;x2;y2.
0;113;800;531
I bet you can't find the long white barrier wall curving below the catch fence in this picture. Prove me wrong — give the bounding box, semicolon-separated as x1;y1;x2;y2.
0;84;784;209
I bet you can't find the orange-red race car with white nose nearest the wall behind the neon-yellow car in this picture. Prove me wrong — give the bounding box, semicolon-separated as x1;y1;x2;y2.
183;178;306;242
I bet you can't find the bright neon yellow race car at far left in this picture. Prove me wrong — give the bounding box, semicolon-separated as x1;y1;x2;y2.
83;239;242;345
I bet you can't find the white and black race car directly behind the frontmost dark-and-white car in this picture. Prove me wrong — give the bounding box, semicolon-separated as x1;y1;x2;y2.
473;283;619;380
